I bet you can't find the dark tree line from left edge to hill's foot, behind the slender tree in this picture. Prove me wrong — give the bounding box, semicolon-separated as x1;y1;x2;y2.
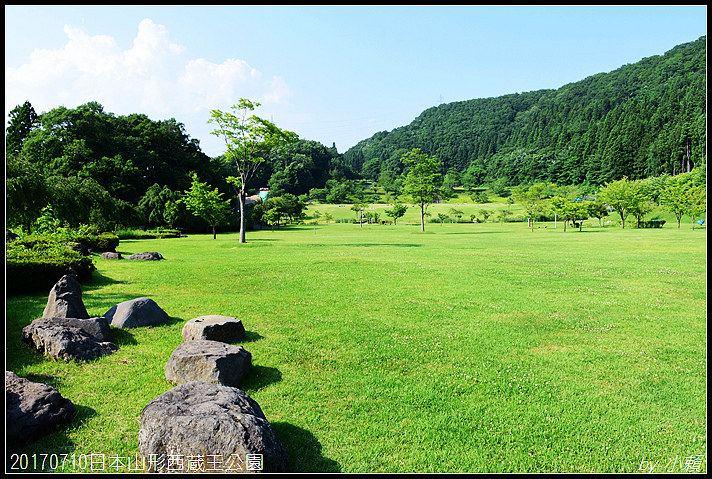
5;101;363;234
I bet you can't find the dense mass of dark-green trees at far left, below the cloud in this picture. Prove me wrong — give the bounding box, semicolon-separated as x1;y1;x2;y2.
7;102;229;231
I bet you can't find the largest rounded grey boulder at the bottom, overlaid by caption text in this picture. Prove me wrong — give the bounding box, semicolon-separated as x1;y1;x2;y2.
138;381;289;472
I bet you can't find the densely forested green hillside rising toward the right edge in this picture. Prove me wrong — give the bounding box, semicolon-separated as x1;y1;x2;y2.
344;37;707;187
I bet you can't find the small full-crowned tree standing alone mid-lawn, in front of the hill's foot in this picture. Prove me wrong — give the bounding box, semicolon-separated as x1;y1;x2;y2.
401;148;445;231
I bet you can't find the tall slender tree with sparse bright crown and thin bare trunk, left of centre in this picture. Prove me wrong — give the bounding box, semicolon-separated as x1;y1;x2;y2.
208;98;299;243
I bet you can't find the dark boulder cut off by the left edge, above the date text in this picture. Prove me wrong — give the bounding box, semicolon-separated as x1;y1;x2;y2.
5;371;74;447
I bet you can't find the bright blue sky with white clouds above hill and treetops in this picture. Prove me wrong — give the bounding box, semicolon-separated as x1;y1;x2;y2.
5;6;707;156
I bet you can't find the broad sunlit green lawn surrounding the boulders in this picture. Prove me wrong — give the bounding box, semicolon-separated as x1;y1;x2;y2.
6;219;707;473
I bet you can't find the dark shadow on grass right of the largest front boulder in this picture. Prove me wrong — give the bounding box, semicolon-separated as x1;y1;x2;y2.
272;422;341;472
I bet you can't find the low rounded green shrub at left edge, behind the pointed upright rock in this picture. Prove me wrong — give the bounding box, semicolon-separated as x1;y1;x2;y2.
5;236;96;294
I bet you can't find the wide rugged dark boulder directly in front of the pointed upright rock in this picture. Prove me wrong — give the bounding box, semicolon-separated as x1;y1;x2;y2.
22;317;119;361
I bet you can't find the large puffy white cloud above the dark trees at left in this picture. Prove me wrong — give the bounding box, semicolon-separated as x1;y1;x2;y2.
5;19;292;154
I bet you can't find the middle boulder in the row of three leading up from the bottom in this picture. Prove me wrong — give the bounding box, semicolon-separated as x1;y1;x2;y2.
164;339;252;387
